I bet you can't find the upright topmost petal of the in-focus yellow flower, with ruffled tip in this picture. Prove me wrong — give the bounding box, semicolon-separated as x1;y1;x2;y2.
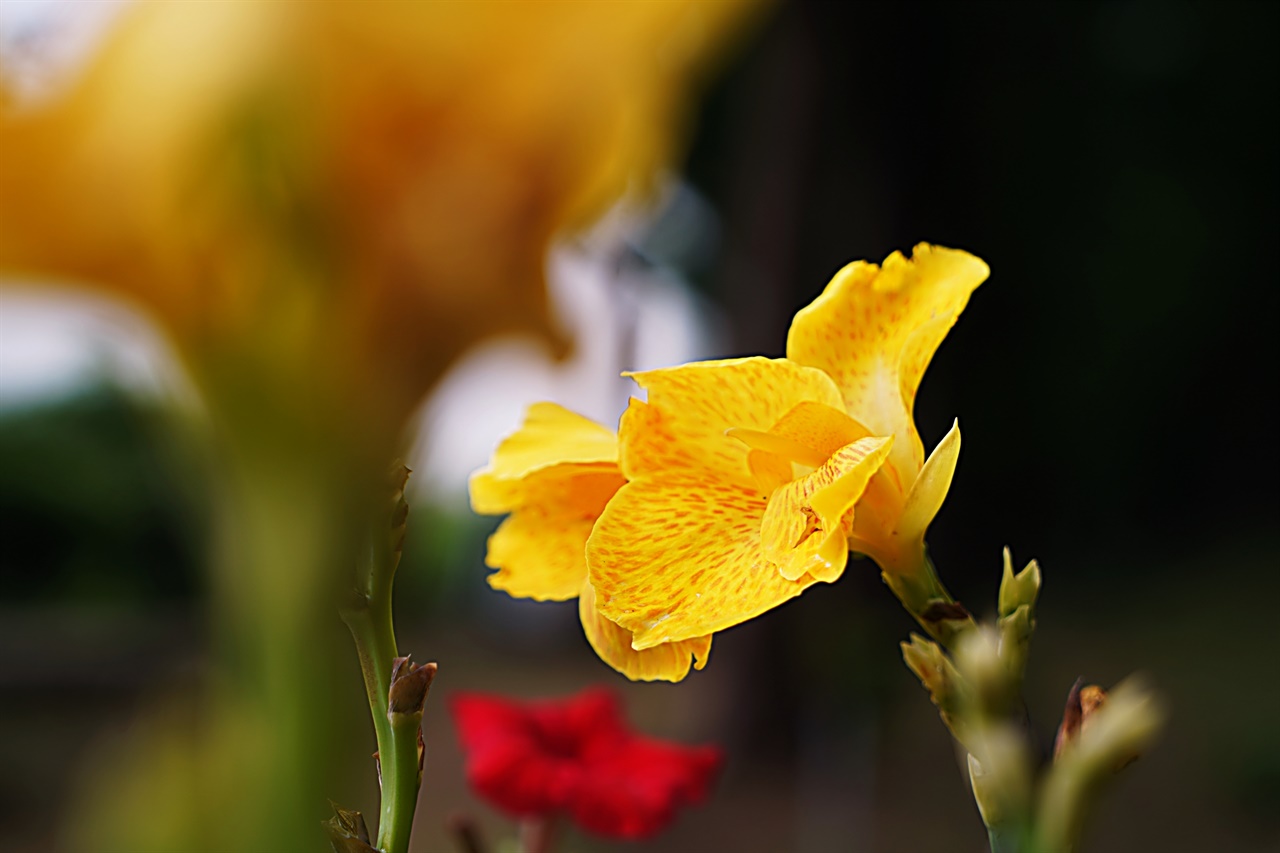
787;243;989;488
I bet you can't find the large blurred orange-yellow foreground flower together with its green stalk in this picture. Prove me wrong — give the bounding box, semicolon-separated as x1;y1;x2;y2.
0;0;750;850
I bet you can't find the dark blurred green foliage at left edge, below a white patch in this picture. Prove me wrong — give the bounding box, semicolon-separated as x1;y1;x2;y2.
0;384;207;602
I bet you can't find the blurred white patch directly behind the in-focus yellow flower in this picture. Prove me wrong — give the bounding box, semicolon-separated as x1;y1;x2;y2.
410;182;723;502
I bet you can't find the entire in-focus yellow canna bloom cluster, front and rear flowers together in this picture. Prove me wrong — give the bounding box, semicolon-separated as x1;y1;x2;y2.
471;245;987;680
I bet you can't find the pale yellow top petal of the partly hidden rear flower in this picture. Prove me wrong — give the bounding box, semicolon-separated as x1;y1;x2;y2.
470;402;618;515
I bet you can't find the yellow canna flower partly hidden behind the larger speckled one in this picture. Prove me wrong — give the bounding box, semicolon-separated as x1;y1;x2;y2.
471;403;712;681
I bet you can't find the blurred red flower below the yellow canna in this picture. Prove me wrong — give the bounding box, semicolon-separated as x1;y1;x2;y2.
451;688;721;839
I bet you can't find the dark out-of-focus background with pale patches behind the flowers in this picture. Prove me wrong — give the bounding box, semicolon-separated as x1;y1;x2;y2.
0;3;1280;853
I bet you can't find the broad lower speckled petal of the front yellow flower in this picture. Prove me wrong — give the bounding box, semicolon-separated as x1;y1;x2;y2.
586;470;814;649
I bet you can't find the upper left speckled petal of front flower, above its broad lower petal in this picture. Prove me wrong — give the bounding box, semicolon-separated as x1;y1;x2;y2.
618;357;842;484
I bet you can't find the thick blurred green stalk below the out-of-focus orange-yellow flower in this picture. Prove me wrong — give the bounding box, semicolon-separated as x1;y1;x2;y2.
209;429;353;849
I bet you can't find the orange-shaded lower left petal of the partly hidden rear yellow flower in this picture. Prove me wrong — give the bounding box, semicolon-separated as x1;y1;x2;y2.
485;464;623;601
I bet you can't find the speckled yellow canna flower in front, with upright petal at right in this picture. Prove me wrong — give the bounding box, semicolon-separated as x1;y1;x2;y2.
586;245;988;649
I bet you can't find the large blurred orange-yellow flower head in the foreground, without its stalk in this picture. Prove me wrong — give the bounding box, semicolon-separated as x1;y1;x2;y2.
0;0;745;424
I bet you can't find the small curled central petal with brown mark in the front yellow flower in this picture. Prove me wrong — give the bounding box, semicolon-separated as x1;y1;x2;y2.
760;438;893;581
